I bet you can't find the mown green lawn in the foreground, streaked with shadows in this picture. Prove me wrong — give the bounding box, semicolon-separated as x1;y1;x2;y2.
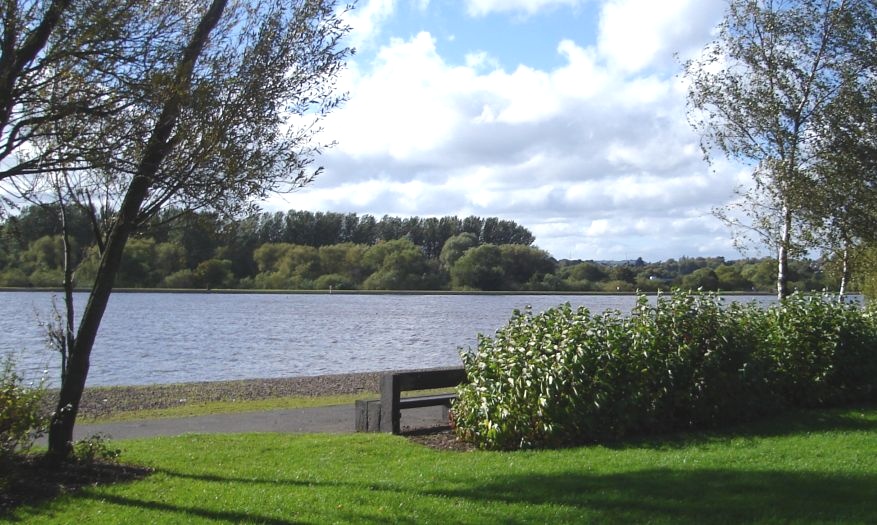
10;408;877;524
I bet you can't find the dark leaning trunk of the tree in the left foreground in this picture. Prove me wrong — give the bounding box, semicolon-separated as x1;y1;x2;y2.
48;0;227;462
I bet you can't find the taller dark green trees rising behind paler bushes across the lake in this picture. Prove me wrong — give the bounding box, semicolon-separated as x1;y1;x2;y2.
0;203;535;263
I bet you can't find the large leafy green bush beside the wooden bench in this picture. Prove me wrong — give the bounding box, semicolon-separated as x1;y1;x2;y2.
453;292;877;449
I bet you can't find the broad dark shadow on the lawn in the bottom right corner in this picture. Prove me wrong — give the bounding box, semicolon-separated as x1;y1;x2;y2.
424;469;877;523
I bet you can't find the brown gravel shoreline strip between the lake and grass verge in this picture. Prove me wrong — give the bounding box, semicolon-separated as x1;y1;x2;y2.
46;372;382;417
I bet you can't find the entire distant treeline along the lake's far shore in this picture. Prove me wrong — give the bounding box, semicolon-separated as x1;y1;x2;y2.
0;207;833;292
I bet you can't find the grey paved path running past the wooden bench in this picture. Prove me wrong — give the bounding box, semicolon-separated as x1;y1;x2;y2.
60;403;447;440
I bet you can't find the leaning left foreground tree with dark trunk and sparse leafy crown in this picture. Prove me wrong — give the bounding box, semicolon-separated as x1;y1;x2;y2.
35;0;350;459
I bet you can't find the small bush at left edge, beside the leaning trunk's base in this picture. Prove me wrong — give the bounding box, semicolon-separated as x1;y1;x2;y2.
0;355;48;463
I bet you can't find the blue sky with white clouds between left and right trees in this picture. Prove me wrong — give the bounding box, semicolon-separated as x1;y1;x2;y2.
266;0;746;261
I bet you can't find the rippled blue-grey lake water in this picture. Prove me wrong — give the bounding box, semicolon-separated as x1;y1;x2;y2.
0;292;766;386
